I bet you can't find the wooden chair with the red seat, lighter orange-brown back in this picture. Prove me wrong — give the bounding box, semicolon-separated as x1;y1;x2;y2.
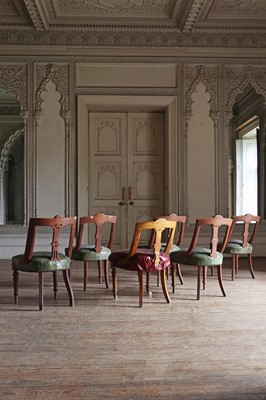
109;218;176;307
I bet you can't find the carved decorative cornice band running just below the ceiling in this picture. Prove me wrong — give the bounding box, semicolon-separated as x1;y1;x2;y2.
0;27;266;48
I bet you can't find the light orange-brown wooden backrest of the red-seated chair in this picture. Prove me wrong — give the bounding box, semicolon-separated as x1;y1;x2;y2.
128;218;176;266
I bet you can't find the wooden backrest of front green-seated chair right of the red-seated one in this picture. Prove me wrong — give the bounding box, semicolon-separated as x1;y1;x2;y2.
187;215;233;257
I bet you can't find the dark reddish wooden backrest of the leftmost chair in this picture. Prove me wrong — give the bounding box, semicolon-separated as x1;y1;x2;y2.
22;215;77;264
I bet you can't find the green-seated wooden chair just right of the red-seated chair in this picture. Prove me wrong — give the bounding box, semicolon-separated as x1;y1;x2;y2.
170;215;232;300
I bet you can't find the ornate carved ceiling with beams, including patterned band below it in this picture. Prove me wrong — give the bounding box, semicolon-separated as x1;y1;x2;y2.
0;0;266;46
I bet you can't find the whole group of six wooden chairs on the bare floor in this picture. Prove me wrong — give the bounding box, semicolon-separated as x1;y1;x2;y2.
12;213;260;310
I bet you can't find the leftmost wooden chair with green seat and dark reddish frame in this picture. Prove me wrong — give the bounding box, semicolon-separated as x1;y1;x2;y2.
12;215;77;310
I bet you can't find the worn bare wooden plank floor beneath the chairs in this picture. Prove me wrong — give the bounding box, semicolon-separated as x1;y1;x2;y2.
0;258;266;400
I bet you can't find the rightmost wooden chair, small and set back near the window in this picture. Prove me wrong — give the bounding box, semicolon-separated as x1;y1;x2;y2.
219;214;261;281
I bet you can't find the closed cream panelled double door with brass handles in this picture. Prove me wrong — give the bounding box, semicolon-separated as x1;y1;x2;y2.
88;112;165;249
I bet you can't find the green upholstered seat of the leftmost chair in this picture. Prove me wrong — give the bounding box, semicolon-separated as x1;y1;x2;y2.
12;251;71;272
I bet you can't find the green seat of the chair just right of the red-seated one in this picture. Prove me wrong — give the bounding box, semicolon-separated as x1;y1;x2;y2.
170;247;223;267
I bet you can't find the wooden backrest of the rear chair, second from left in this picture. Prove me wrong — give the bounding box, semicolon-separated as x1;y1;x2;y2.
75;213;117;253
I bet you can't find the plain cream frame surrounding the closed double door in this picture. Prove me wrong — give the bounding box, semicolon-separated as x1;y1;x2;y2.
77;95;179;223
